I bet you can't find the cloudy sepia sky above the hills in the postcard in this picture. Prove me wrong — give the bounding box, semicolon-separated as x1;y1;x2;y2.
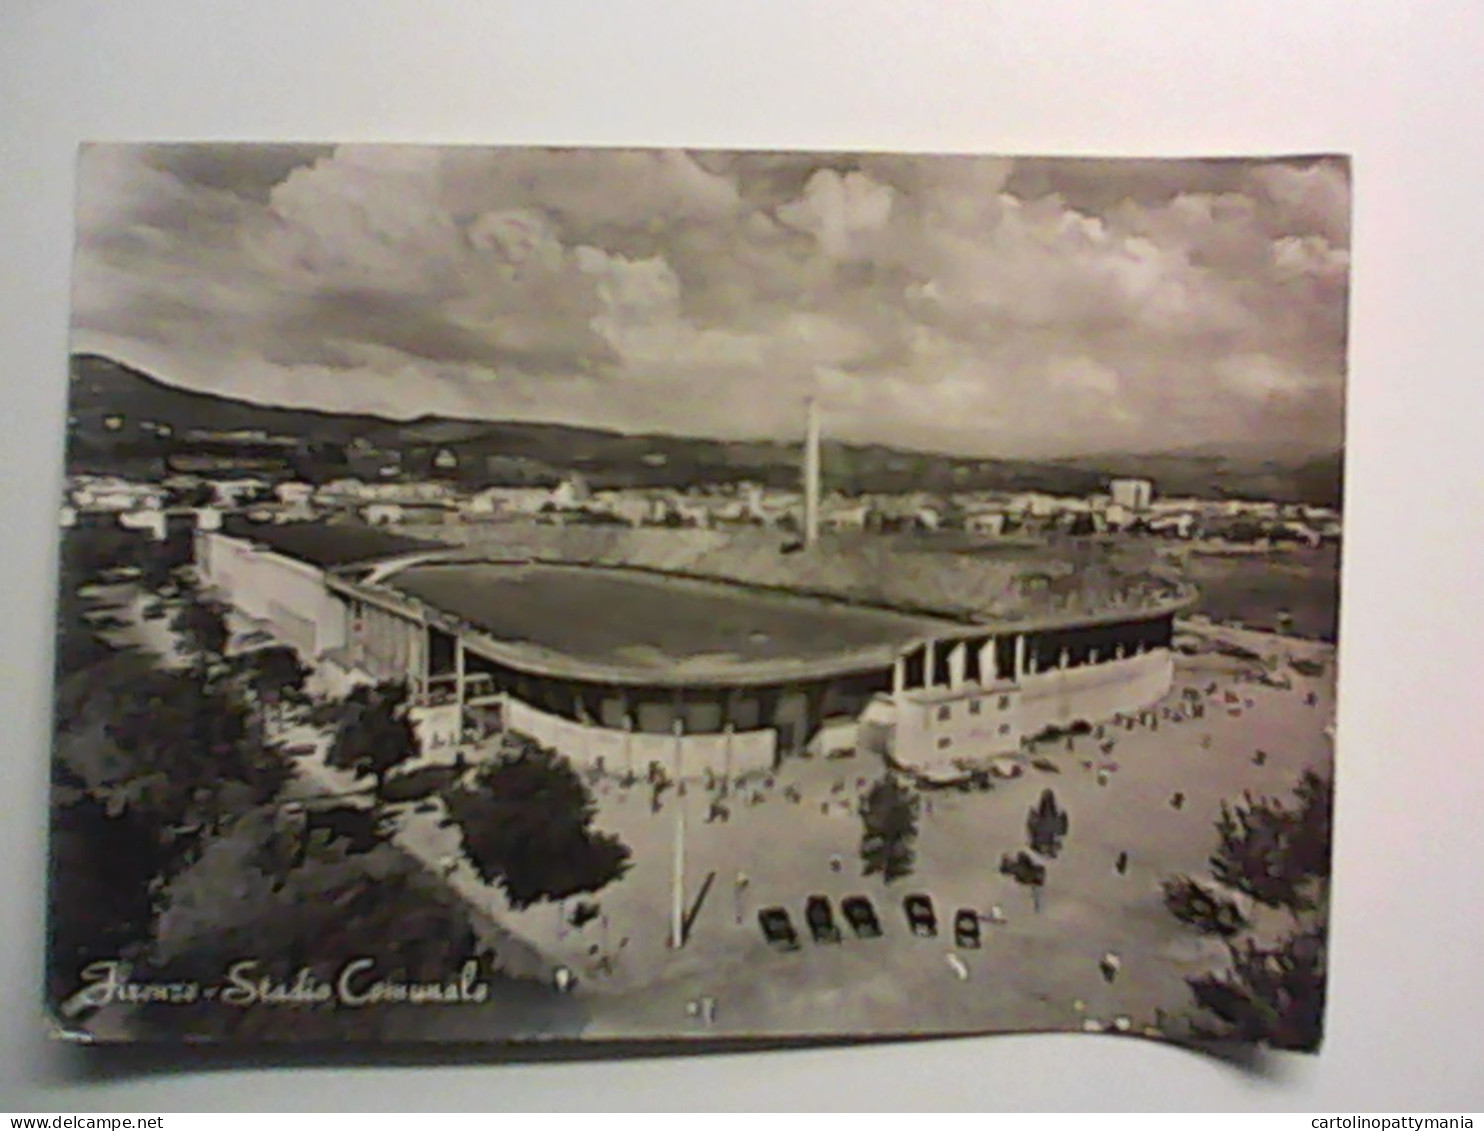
73;145;1349;456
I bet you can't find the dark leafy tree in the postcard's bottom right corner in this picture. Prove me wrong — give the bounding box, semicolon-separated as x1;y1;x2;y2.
1187;929;1325;1051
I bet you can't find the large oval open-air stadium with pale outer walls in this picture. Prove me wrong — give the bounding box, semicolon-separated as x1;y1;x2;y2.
196;507;1193;778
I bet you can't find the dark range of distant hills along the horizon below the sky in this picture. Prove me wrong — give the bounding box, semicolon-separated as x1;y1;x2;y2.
67;355;1342;505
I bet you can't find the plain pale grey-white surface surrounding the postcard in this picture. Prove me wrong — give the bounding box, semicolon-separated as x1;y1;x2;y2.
0;0;1484;1112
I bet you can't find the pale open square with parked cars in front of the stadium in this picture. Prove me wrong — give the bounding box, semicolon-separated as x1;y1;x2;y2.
483;620;1333;1036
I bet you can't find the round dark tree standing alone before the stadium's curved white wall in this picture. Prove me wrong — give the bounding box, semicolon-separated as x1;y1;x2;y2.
445;735;631;908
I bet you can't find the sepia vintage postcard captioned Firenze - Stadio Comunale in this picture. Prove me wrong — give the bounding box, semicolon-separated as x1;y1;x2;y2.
46;144;1350;1049
